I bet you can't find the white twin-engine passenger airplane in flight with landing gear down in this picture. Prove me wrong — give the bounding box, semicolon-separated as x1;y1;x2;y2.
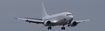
15;1;90;30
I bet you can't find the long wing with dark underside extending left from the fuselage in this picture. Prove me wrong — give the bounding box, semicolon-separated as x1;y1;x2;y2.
16;18;44;24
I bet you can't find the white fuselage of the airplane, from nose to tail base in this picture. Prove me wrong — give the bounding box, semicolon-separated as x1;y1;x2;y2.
44;12;73;26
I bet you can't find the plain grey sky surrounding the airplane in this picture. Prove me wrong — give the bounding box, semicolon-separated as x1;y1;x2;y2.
0;0;105;31
